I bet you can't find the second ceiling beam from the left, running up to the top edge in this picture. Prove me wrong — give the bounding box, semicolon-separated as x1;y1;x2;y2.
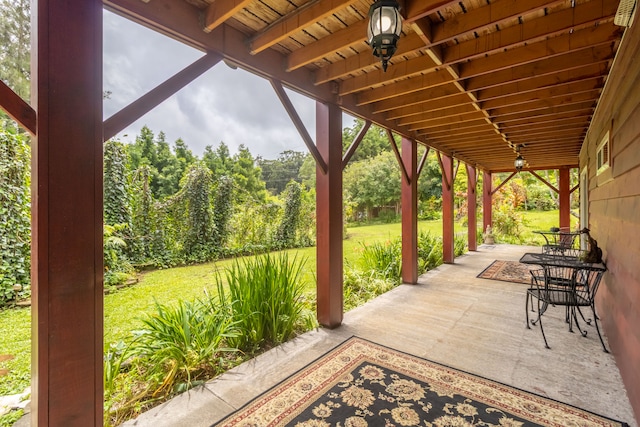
250;0;366;55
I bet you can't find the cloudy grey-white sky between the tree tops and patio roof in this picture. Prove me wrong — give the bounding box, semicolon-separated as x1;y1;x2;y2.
104;10;352;159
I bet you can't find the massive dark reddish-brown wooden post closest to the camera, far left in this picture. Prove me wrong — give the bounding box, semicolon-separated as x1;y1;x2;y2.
31;0;103;427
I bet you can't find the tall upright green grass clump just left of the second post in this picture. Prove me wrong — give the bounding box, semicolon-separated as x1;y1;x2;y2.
217;253;315;353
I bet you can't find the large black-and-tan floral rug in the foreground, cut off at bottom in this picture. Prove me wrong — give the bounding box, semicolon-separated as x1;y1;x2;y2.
215;337;626;427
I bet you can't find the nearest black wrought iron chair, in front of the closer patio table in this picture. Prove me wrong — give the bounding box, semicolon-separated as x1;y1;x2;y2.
525;267;609;353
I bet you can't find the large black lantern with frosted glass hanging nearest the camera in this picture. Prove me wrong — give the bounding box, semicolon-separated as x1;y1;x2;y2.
367;0;402;71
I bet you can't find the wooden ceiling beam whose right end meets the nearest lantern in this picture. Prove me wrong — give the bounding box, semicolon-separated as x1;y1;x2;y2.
286;19;368;71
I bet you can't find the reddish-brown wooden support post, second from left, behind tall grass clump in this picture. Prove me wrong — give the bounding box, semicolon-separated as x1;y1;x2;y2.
316;102;343;328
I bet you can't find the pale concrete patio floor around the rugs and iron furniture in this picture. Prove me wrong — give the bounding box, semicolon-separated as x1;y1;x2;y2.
123;245;638;427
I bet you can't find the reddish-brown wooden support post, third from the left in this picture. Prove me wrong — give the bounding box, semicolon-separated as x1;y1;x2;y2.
401;137;418;284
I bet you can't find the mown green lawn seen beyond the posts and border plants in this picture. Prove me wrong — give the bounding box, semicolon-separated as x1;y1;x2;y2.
0;211;558;395
